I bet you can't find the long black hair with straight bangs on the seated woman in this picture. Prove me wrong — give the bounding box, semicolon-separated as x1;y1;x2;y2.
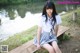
42;1;57;29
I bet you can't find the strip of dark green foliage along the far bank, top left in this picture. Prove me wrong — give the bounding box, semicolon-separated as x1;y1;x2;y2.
0;0;46;5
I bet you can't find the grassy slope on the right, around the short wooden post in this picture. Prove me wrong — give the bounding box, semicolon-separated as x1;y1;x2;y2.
61;8;80;26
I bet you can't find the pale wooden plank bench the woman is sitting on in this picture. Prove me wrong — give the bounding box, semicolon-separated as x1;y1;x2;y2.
9;26;69;53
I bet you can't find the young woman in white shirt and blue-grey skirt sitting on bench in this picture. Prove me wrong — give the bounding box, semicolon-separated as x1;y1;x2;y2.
34;2;62;53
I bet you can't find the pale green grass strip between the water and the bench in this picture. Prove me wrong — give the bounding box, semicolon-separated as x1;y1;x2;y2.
0;26;37;51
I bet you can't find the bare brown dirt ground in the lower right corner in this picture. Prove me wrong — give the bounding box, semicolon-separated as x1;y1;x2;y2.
60;24;80;53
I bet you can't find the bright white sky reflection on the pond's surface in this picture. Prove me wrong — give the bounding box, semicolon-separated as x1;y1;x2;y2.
0;10;41;39
